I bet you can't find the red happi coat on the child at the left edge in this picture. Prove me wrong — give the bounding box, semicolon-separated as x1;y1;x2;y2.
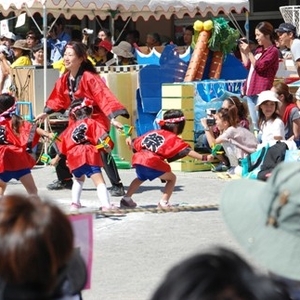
0;119;39;173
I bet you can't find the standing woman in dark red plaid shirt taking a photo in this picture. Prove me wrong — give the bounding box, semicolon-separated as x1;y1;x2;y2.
239;22;279;132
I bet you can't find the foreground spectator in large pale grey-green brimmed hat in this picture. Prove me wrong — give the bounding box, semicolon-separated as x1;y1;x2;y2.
220;162;300;300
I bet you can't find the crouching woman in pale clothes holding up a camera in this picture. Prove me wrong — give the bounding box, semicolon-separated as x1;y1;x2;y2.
201;105;257;173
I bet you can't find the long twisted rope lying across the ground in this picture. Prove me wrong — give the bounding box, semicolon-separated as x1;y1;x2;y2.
69;204;219;216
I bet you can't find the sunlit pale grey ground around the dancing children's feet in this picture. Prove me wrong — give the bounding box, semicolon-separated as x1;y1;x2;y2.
7;166;253;300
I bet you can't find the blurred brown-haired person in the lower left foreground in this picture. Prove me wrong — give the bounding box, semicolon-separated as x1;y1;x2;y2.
0;194;87;300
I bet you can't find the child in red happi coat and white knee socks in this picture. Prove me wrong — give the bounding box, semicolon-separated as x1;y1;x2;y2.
51;98;114;212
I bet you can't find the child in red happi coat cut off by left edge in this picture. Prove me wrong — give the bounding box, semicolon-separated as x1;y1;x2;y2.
0;94;52;196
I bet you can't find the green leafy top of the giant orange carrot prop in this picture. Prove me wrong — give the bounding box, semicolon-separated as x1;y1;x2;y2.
208;18;240;54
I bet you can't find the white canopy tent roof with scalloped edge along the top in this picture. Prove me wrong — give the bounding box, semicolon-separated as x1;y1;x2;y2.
0;0;249;21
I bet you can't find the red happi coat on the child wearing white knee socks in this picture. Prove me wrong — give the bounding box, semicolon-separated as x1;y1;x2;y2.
56;119;107;171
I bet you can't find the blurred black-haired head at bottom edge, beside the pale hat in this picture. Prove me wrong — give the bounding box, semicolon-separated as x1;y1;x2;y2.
151;247;290;300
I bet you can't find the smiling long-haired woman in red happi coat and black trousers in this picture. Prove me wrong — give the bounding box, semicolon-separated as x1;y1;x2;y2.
36;42;129;196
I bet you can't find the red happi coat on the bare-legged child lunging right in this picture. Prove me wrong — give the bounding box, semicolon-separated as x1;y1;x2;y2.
132;129;192;172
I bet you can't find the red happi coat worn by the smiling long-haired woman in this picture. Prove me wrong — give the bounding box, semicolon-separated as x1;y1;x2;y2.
44;71;129;132
